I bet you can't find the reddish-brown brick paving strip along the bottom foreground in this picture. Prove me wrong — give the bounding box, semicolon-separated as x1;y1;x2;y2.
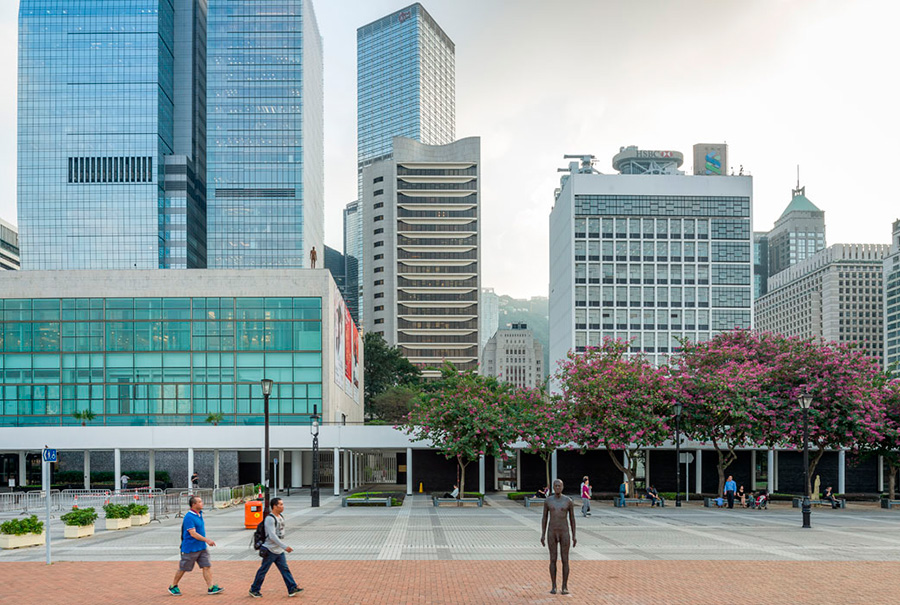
0;561;900;605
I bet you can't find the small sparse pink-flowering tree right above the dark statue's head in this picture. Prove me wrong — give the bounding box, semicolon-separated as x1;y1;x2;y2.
510;388;572;489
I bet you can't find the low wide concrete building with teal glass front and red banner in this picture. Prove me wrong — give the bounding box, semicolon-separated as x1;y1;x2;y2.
0;269;364;485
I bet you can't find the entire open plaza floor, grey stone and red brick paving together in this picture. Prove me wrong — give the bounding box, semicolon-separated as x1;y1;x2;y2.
0;495;900;604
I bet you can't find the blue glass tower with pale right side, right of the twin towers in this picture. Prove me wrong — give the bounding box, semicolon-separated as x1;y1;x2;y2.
207;0;325;268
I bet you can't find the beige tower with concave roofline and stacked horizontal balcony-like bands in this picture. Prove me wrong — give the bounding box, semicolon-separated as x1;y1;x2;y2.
362;137;481;377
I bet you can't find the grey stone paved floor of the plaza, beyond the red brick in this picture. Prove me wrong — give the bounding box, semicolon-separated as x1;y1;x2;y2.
0;494;900;563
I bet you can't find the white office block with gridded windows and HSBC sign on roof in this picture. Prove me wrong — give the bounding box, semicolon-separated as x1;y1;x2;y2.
549;147;753;368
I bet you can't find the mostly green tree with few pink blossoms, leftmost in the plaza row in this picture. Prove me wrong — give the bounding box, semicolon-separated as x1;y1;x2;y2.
397;363;516;497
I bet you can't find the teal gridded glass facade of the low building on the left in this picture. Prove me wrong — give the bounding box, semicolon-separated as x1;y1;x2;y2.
0;297;330;426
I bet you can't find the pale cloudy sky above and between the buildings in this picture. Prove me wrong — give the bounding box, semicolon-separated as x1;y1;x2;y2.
0;0;900;298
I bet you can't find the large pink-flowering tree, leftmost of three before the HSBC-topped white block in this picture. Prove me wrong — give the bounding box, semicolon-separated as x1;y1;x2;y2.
556;339;673;494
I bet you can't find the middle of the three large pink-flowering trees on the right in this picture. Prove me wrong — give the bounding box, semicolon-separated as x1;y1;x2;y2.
670;330;769;494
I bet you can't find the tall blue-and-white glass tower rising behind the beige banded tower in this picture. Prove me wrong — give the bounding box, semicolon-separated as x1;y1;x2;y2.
356;3;456;321
